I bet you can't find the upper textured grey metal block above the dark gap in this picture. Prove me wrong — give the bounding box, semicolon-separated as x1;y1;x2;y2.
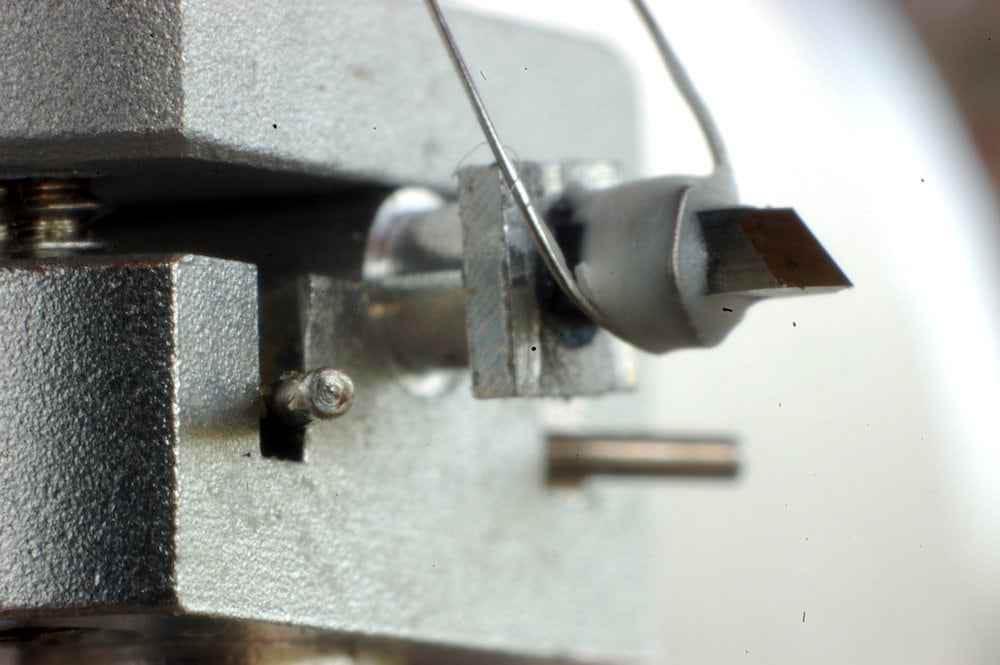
0;0;638;196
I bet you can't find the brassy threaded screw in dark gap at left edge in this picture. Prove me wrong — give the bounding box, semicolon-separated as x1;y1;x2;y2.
0;178;103;258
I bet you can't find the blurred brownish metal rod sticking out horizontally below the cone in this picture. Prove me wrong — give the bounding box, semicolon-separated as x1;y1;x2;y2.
548;434;739;480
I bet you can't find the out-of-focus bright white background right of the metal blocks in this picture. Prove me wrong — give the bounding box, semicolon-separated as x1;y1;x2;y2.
458;0;1000;664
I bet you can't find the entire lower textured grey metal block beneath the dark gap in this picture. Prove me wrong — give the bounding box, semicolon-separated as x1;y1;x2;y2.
0;257;657;661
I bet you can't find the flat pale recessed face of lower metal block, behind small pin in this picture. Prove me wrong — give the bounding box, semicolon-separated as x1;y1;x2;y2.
177;277;656;661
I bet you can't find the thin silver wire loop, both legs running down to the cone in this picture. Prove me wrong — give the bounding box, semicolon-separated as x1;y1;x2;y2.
424;0;729;327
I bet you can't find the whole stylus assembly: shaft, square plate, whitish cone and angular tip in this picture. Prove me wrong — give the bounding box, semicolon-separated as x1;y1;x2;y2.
364;167;850;398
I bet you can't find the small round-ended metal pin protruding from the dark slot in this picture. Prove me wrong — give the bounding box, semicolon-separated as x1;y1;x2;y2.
264;367;354;427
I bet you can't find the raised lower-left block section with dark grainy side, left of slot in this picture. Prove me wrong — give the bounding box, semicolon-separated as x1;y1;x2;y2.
0;257;258;616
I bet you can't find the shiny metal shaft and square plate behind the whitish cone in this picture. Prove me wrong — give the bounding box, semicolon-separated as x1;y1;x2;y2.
364;174;634;397
